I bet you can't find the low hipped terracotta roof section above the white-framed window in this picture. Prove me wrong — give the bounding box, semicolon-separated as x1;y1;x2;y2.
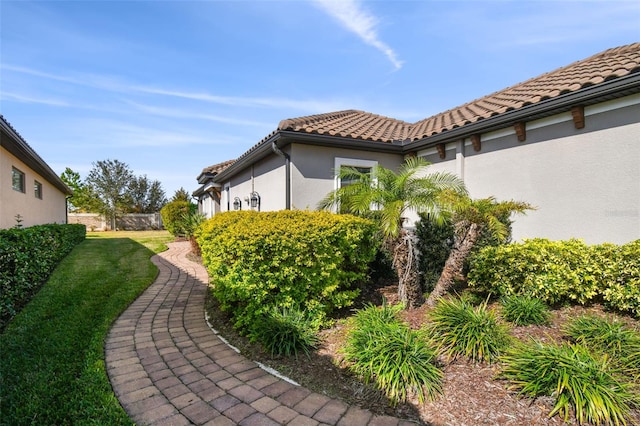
278;110;411;142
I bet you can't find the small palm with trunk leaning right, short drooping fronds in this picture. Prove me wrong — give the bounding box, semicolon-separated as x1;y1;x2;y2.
426;193;534;306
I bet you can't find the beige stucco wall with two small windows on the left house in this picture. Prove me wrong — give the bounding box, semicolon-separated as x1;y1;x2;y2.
0;147;66;228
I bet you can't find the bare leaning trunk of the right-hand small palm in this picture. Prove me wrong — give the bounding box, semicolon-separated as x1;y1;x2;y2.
426;223;481;306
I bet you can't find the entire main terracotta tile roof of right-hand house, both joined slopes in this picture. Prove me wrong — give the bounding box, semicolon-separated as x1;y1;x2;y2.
278;43;640;142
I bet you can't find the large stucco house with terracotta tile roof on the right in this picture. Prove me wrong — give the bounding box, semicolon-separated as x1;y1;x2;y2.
194;43;640;244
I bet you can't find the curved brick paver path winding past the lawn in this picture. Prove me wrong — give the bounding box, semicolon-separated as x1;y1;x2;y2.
105;242;412;426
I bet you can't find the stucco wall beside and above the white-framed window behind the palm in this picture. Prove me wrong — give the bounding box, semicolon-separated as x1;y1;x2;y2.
291;144;403;210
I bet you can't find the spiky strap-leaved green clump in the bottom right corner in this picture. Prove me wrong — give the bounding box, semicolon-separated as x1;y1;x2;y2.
500;342;634;425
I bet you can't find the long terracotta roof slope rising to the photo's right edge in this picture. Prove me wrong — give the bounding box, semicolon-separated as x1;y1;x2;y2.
409;43;640;140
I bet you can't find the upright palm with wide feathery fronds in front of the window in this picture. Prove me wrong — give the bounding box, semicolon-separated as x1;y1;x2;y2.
319;157;466;307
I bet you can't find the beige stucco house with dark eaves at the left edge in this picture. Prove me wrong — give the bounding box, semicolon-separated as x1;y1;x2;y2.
0;115;73;229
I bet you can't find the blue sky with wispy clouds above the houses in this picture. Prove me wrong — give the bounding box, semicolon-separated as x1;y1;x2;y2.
0;0;640;198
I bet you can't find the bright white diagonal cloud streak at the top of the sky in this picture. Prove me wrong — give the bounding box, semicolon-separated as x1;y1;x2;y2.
314;0;402;70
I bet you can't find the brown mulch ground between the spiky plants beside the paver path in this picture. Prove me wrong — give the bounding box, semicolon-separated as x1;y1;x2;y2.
192;257;640;426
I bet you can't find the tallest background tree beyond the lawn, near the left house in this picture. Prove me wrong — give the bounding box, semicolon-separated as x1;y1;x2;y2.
86;160;134;229
